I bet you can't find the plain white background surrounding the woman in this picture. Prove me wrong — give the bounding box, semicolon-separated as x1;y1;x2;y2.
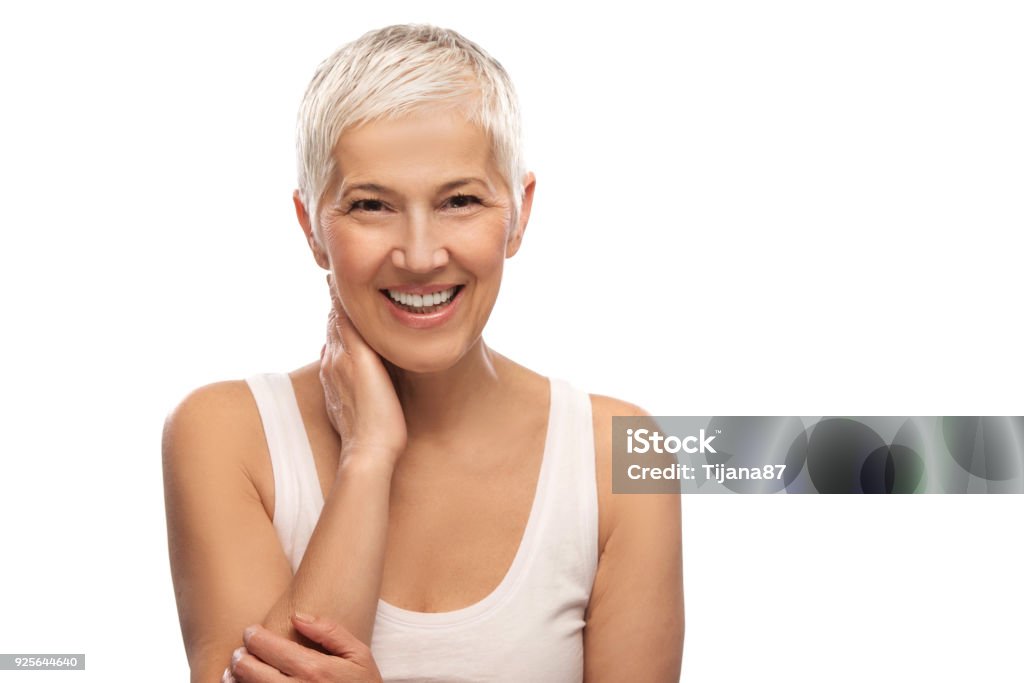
0;0;1024;682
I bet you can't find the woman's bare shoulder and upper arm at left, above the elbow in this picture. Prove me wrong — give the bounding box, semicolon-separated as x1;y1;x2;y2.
163;380;291;680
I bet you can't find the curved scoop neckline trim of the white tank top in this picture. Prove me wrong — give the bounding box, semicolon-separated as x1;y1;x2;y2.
377;377;559;628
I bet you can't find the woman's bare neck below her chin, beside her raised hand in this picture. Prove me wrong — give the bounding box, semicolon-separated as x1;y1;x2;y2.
386;337;505;439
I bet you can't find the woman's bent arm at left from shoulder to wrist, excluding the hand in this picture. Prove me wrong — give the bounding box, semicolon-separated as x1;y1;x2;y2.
164;382;390;683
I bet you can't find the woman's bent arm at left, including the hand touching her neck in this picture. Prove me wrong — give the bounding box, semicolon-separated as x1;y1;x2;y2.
164;278;406;681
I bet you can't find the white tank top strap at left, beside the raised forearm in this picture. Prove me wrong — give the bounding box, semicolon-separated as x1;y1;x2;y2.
246;373;324;572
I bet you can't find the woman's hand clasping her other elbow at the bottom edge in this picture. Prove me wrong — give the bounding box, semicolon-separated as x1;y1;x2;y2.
221;617;381;683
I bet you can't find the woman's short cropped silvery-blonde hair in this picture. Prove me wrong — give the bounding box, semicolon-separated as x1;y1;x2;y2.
296;24;526;244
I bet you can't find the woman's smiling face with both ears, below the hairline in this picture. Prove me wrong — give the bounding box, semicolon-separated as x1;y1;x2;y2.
296;110;534;373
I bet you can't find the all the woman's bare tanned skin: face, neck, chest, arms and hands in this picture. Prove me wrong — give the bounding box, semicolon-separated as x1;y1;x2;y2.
164;104;683;683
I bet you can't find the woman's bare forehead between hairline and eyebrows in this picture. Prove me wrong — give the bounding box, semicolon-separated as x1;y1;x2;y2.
334;110;499;185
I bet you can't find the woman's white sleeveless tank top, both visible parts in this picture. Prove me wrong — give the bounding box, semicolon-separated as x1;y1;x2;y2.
246;373;597;683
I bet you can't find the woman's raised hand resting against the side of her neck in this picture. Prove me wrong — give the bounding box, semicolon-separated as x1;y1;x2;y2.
319;273;407;466
